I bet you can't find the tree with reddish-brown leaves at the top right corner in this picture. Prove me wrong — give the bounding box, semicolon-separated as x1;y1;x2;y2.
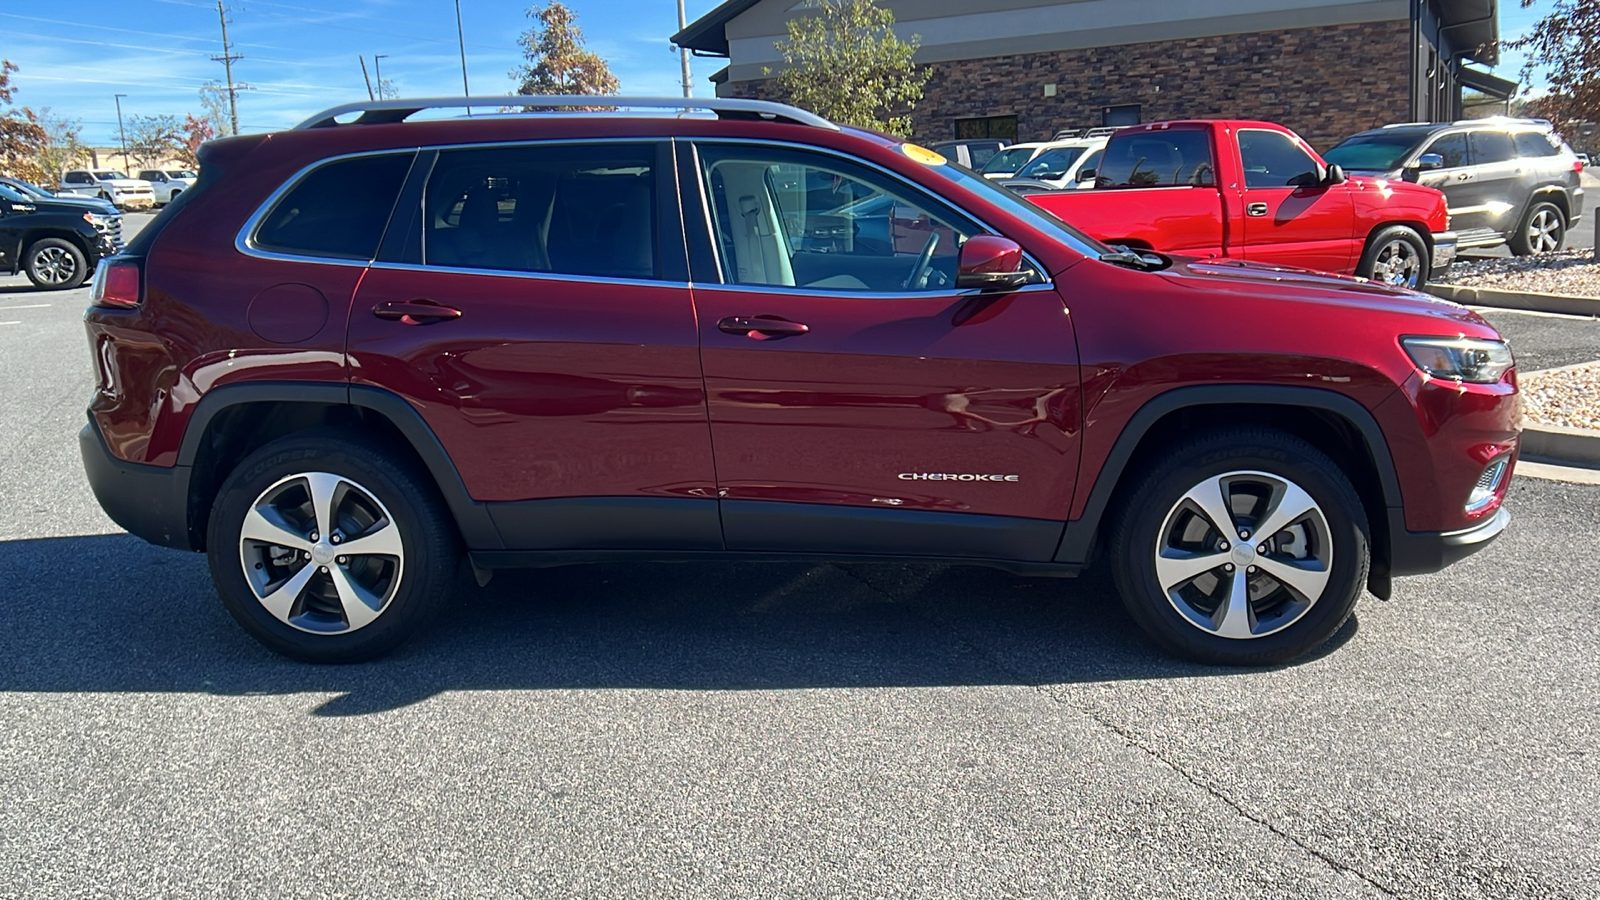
1504;0;1600;127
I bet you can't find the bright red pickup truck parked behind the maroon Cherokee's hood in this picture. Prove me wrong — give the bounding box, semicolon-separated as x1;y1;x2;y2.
1027;120;1456;288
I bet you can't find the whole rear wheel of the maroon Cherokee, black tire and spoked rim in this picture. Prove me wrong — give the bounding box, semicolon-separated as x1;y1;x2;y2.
206;431;461;663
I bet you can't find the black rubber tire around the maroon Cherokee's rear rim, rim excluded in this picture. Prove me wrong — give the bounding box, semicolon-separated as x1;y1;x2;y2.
206;439;454;663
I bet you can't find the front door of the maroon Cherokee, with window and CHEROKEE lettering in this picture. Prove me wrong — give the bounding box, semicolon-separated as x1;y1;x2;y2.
683;143;1082;560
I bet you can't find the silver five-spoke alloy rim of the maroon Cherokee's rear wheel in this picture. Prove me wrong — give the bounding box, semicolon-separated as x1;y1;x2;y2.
238;472;405;634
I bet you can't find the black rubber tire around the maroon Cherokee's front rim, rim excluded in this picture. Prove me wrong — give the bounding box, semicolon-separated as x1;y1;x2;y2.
1115;439;1370;665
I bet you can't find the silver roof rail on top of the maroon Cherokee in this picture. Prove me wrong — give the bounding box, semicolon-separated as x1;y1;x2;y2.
294;94;838;131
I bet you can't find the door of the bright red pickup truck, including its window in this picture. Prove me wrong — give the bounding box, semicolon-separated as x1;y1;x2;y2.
1237;128;1365;272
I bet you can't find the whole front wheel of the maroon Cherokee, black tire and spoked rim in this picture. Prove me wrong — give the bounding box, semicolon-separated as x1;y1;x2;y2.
1110;428;1371;666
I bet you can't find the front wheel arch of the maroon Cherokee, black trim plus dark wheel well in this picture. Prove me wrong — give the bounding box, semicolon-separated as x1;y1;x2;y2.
1054;384;1402;597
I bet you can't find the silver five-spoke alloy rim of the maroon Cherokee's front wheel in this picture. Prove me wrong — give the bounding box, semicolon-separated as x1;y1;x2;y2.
1155;471;1333;641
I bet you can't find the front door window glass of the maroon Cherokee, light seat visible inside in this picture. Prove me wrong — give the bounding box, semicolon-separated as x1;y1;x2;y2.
701;144;979;293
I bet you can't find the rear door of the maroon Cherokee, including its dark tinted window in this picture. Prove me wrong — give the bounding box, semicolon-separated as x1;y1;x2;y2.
349;141;722;549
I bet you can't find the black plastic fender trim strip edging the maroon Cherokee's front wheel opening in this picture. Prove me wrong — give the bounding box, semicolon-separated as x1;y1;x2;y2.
1054;384;1402;565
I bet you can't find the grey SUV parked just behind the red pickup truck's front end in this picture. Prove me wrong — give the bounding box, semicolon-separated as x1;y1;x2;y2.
1326;119;1584;256
